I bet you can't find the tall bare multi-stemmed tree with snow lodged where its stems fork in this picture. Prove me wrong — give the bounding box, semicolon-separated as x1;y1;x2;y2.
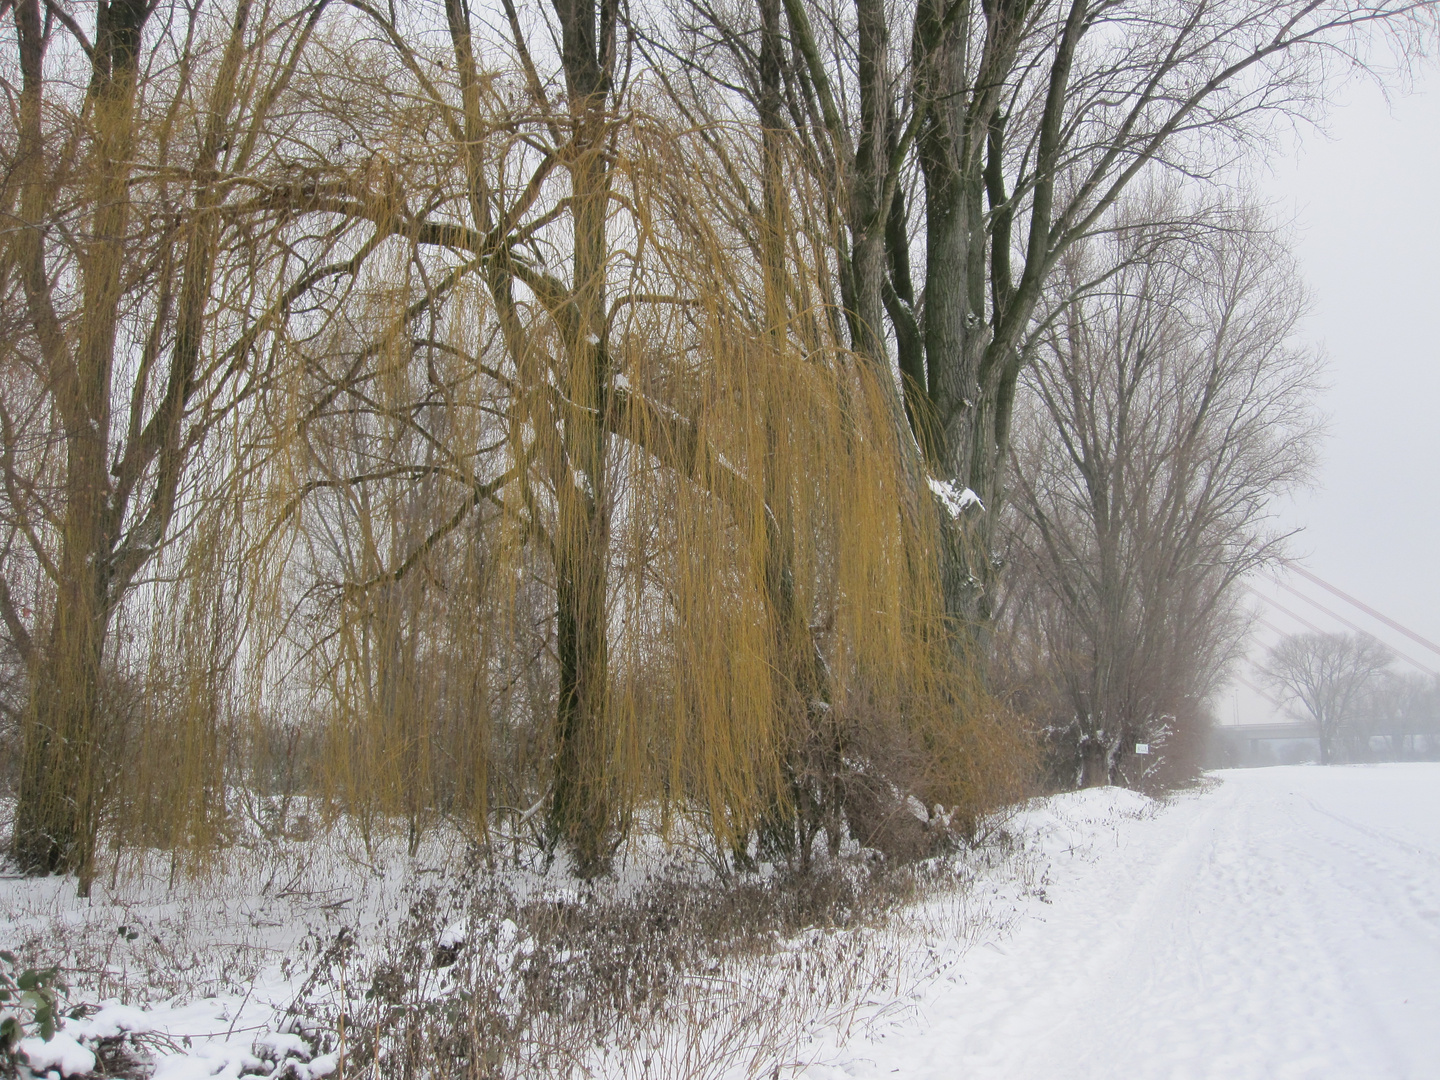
656;0;1434;624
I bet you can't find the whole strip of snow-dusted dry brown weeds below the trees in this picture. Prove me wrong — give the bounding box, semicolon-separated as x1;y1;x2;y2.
7;806;1024;1077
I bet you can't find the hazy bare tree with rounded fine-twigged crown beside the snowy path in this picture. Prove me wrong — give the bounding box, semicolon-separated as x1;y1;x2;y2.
1009;194;1319;783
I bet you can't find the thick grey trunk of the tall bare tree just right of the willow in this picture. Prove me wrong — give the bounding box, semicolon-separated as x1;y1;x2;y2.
914;0;1084;633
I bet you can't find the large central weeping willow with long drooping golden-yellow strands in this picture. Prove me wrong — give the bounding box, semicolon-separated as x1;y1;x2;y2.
258;4;1014;871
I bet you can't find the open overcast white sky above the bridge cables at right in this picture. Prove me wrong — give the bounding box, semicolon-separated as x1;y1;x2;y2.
1217;65;1440;723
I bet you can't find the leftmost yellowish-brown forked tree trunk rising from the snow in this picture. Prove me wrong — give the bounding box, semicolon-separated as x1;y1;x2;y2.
14;0;150;896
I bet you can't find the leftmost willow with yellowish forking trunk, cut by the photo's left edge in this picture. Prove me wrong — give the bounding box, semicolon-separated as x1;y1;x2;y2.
0;0;331;893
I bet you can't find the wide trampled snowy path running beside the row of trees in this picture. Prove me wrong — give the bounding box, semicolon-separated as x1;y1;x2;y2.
805;765;1440;1080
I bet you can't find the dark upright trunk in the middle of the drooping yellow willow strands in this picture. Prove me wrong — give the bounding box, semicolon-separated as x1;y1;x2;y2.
445;0;616;876
